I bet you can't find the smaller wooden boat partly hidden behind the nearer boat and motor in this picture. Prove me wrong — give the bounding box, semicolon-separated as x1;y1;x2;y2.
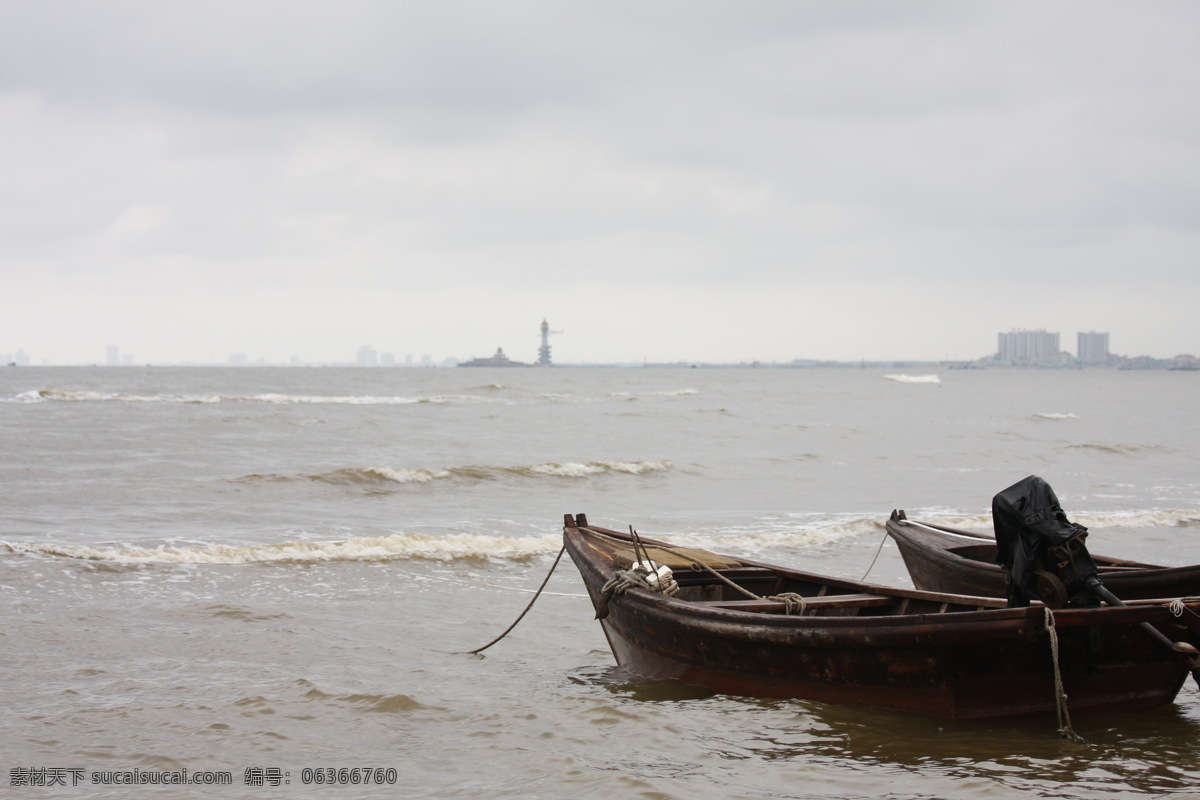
887;511;1200;600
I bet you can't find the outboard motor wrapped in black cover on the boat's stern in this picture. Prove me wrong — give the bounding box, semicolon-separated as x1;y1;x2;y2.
991;475;1111;608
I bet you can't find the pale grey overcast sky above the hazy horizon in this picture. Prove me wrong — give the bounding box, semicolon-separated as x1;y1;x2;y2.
0;0;1200;363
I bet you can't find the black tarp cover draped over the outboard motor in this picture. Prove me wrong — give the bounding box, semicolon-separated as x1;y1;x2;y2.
991;475;1086;607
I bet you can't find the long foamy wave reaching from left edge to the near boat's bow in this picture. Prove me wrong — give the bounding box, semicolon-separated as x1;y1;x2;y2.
6;534;562;564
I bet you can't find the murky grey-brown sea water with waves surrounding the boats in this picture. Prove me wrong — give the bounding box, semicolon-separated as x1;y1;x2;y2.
0;367;1200;800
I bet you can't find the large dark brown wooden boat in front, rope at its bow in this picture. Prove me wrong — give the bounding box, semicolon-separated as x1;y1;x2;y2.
563;515;1200;718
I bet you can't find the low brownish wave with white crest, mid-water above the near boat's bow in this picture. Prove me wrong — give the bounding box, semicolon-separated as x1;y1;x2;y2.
238;461;672;488
